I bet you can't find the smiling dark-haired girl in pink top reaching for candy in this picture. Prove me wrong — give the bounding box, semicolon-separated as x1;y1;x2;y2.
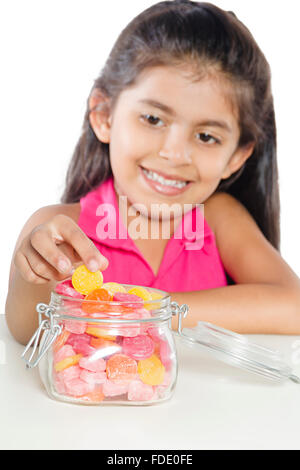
6;0;300;343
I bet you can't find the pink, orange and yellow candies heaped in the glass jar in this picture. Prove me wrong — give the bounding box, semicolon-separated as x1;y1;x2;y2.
52;276;174;404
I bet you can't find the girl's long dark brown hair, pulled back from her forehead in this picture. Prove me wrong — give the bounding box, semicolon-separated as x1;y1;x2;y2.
61;0;280;255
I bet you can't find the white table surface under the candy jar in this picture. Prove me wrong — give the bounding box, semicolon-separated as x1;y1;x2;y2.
0;315;300;450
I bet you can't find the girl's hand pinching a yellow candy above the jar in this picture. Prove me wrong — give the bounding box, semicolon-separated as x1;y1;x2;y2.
13;214;108;284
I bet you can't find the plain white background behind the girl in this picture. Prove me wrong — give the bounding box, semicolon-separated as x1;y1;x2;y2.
0;0;300;312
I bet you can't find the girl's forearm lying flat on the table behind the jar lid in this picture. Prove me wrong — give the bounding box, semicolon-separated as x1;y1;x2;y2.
171;284;300;335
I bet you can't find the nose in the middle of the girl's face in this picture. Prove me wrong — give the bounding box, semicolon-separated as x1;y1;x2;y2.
159;127;192;165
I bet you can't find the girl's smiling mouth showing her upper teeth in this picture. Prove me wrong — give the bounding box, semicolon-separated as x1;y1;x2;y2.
140;167;191;196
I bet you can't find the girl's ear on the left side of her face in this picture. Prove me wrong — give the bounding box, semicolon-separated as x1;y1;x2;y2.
89;88;111;144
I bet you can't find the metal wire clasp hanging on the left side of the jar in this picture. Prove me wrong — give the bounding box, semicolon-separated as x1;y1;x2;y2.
21;304;62;369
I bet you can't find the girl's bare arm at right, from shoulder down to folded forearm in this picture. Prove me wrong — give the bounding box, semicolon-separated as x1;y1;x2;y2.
172;193;300;335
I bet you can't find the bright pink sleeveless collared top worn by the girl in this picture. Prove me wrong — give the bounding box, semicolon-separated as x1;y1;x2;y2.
78;177;227;292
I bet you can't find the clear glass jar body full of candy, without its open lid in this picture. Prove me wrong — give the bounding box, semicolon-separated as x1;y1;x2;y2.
23;284;187;405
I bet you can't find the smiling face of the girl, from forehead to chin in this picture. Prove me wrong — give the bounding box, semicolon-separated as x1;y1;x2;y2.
93;66;253;218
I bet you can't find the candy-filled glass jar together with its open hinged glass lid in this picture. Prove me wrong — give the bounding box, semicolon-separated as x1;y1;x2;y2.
22;284;300;405
